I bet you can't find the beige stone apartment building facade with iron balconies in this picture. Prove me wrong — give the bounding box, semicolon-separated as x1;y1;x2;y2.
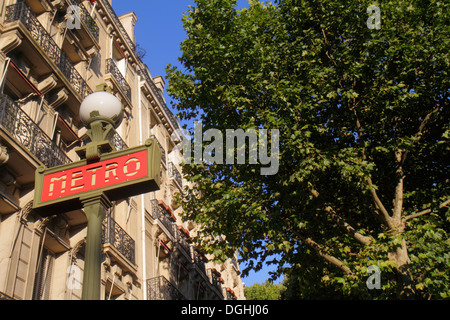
0;0;244;300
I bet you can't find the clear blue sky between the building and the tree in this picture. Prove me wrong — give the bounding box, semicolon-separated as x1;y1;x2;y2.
112;0;278;286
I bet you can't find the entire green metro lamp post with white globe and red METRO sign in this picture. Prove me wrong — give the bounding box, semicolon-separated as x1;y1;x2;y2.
33;86;161;300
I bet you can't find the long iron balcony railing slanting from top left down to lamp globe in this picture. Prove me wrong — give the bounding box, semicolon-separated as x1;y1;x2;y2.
5;2;92;98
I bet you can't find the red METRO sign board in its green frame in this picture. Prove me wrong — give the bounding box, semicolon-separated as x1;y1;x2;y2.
34;139;161;216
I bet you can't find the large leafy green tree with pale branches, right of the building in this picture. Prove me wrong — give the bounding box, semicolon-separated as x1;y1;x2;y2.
167;0;450;299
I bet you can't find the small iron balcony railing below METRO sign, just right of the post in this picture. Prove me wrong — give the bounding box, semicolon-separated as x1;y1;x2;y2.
102;216;135;264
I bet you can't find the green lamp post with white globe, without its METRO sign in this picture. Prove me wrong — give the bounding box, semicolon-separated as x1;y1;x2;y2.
76;87;123;300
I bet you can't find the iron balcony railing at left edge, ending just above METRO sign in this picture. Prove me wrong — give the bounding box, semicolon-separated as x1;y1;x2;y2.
0;95;70;168
